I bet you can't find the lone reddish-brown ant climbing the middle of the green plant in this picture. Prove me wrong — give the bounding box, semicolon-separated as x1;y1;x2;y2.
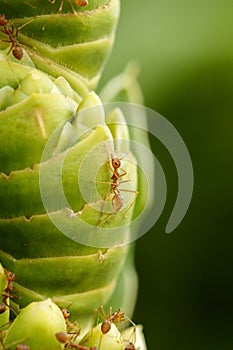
98;154;138;225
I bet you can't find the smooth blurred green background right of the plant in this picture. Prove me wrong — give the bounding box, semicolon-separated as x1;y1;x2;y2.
100;0;233;350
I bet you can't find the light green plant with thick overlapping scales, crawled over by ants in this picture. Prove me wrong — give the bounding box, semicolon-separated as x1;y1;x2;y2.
0;0;149;350
